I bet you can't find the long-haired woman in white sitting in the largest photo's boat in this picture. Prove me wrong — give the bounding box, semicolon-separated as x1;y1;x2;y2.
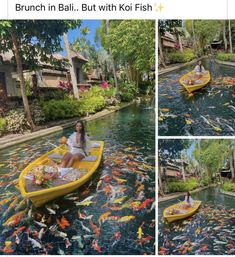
59;121;91;168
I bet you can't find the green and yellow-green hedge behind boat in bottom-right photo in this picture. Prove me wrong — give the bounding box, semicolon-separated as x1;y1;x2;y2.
167;178;199;193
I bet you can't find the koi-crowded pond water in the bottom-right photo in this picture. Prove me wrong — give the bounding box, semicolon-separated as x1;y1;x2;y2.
158;188;235;255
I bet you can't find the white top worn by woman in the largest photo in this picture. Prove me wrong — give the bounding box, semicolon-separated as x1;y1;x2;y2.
67;132;91;156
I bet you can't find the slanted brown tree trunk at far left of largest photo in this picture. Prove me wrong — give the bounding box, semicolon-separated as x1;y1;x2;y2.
11;32;36;131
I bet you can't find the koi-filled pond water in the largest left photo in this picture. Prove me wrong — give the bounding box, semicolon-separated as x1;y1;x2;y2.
0;100;155;255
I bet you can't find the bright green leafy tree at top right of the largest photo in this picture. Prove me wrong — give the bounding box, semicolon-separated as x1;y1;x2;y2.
98;20;155;84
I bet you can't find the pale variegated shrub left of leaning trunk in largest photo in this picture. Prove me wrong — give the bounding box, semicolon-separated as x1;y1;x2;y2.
5;109;30;133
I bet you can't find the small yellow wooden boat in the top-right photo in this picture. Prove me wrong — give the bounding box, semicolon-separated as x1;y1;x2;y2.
179;71;211;94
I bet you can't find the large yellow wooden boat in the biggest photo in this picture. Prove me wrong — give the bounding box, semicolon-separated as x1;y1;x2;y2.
19;141;104;207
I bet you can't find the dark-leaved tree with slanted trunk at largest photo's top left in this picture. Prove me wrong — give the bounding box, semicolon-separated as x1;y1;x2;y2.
0;20;80;130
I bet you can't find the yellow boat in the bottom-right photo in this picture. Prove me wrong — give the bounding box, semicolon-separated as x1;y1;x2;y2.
163;200;202;222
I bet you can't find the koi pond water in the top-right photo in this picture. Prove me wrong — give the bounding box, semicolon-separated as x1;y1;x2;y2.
158;58;235;136
